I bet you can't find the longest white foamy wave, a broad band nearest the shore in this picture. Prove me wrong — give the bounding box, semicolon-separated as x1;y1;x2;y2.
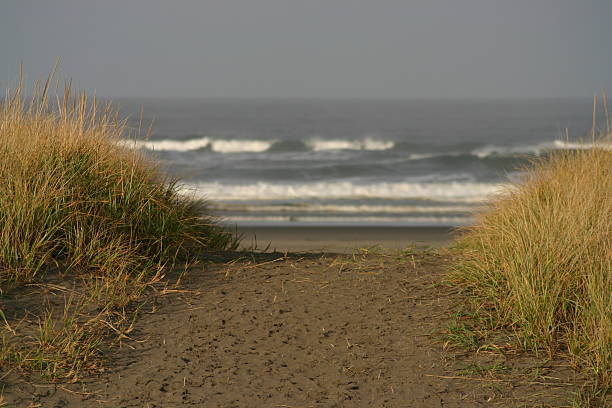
183;181;508;203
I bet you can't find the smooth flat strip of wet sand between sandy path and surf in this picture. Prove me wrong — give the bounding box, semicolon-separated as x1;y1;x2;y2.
237;226;457;253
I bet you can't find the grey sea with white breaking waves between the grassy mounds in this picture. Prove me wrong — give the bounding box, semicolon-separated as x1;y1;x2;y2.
115;98;604;227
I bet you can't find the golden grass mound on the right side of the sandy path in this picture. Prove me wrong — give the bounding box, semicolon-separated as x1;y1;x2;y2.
455;138;612;388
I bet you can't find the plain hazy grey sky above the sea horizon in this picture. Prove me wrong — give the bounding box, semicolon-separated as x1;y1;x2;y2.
0;0;612;98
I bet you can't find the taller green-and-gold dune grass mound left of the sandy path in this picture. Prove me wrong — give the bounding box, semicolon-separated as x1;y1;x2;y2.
0;75;236;377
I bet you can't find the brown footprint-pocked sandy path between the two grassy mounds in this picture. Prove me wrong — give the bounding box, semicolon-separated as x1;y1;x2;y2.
3;229;588;408
